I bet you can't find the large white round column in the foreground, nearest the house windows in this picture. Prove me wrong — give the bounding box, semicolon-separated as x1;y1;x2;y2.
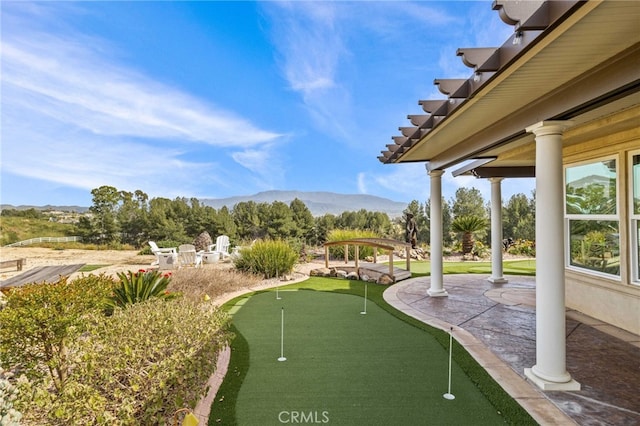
525;121;580;390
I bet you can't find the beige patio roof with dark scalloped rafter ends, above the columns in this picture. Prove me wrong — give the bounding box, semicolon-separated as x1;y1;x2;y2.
378;1;640;177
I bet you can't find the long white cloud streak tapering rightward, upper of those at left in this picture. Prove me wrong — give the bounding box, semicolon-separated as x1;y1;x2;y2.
2;35;280;146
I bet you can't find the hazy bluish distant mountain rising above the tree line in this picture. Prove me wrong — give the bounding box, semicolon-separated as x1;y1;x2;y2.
200;191;408;219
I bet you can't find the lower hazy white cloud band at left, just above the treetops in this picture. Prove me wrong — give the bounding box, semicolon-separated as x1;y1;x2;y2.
2;101;224;197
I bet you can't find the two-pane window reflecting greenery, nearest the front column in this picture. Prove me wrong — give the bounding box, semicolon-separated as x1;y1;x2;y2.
565;159;620;277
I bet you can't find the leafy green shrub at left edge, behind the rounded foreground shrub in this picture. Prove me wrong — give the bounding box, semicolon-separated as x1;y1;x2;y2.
0;275;114;392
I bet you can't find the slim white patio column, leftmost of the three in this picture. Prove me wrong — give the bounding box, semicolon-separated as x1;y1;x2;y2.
427;170;449;297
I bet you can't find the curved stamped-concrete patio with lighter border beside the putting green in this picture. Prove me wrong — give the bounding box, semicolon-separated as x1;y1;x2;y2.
384;274;640;425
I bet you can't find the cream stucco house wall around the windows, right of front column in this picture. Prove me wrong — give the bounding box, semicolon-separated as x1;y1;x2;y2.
563;107;640;334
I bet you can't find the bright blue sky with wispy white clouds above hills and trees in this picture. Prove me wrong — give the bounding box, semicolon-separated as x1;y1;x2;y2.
0;0;535;206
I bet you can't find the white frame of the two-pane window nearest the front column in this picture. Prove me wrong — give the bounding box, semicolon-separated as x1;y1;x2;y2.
562;154;620;281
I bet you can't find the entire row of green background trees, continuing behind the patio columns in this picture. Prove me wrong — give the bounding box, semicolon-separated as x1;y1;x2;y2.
2;186;535;247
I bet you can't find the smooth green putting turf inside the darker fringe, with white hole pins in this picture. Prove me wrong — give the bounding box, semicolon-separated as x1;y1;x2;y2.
225;284;505;425
